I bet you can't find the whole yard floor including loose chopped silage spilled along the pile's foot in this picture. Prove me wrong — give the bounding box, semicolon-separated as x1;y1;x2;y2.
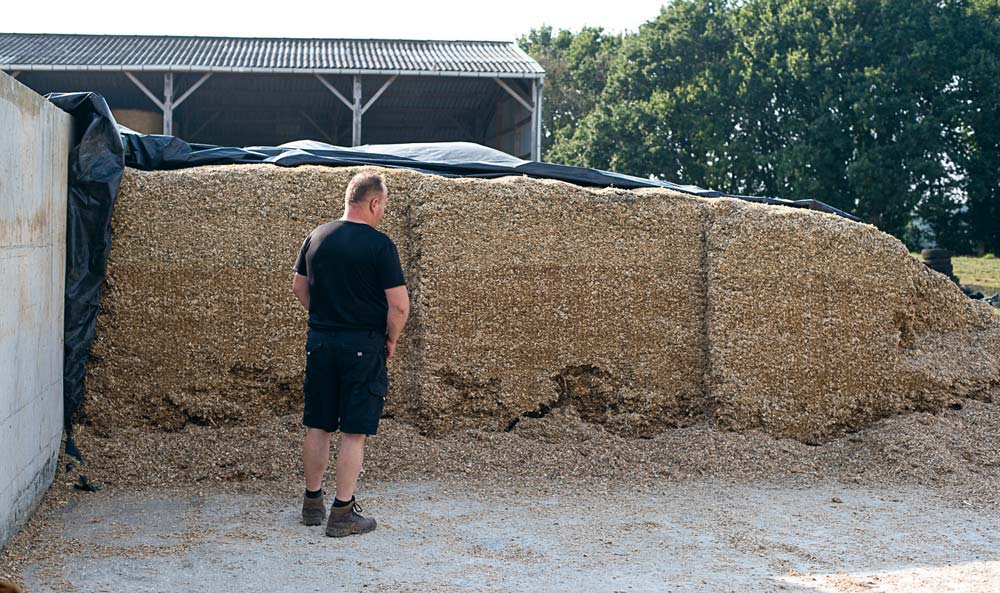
0;400;1000;592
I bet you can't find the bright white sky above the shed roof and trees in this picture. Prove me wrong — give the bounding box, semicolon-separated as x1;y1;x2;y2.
7;0;668;41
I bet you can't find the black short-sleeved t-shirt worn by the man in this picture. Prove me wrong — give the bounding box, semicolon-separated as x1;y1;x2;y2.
295;220;406;333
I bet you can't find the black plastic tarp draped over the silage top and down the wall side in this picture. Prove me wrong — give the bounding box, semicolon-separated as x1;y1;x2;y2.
46;93;858;457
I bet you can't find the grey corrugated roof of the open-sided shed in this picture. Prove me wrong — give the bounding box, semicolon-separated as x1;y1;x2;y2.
0;33;544;78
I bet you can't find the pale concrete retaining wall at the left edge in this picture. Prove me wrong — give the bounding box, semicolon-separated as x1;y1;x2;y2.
0;72;72;546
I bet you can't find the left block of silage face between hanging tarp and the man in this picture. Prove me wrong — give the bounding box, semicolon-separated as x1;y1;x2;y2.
85;166;407;429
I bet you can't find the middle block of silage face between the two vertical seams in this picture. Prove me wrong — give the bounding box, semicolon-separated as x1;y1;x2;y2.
409;173;705;433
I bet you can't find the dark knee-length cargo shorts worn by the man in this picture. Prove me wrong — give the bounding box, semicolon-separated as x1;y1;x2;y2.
302;328;389;435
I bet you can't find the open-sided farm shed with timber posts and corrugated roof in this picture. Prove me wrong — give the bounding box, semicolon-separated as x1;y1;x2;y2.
0;33;545;160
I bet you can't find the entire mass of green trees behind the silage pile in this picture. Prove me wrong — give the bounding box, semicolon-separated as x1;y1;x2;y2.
519;0;1000;255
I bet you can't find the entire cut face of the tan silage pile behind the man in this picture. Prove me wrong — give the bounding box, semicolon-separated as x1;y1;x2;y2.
85;165;1000;441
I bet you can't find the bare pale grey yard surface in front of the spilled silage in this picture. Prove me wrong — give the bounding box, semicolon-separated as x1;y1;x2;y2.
1;480;1000;593
